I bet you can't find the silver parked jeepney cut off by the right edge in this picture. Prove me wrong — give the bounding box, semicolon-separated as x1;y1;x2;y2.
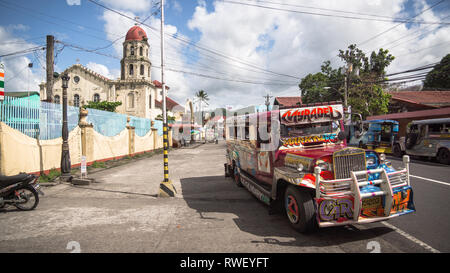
397;118;450;164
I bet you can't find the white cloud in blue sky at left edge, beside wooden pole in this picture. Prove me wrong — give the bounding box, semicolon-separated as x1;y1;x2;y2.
0;26;45;92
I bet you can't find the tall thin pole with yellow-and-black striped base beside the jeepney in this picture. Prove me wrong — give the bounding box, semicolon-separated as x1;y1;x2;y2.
159;0;177;197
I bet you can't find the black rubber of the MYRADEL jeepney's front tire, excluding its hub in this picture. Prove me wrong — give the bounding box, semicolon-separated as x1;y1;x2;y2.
284;185;318;233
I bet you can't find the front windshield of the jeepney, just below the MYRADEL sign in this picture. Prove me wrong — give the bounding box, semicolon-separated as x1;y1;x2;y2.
281;121;339;137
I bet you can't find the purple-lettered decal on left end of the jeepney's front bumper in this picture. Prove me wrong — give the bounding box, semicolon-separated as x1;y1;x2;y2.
316;196;354;222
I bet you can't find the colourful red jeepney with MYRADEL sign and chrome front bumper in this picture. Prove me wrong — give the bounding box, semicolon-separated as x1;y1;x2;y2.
224;103;415;232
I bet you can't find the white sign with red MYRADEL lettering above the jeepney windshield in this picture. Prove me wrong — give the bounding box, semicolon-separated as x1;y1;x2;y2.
280;105;343;124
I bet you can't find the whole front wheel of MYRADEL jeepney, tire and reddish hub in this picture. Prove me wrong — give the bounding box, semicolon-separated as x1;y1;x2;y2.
284;185;317;232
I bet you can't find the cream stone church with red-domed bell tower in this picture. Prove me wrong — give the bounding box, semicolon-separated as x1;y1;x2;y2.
39;25;184;120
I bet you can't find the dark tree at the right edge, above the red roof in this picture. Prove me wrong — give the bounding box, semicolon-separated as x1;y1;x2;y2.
423;54;450;90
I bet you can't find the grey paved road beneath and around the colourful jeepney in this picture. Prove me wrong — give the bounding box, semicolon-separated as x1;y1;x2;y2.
0;144;450;253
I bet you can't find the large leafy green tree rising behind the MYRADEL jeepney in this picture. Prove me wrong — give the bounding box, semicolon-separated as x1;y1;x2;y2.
299;45;394;118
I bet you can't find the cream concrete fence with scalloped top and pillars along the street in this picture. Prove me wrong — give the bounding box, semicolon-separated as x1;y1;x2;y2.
0;109;172;175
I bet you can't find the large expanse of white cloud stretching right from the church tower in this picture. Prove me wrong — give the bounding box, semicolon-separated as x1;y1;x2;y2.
96;0;450;108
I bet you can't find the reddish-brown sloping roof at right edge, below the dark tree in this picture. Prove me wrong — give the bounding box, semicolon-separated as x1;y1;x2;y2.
388;90;450;113
